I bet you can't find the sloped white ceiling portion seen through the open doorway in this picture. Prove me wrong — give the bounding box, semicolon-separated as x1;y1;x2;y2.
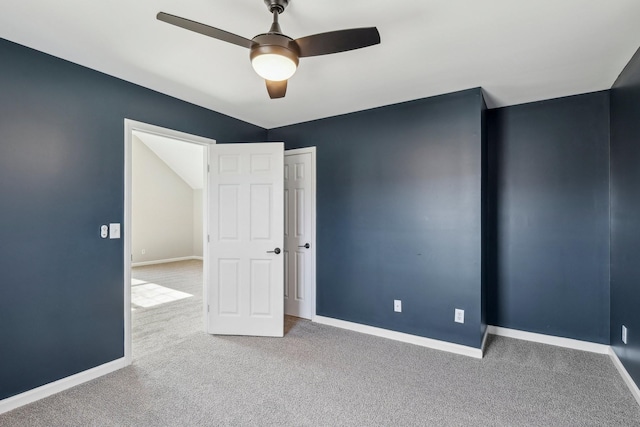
133;131;204;189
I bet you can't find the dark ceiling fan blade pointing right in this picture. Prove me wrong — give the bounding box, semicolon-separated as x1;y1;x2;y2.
295;27;380;58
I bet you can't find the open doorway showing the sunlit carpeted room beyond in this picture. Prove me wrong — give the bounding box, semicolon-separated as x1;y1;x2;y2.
124;120;215;363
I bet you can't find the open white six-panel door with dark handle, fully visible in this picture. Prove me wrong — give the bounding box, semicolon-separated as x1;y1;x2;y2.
208;143;284;337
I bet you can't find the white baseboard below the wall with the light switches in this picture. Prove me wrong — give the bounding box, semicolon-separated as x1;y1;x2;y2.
0;357;127;414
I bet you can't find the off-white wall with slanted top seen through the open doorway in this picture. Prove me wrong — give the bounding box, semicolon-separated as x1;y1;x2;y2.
131;136;202;263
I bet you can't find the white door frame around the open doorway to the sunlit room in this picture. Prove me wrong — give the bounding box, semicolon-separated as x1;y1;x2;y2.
122;119;216;365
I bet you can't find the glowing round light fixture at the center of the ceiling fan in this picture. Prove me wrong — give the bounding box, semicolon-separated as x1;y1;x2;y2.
251;45;298;82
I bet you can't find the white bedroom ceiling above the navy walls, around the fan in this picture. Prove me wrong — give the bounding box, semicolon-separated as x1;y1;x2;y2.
0;0;640;128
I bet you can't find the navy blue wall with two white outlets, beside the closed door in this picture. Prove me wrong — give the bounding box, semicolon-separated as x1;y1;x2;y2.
269;89;483;347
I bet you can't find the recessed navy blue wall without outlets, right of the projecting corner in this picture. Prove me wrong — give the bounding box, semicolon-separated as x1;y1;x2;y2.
487;92;609;344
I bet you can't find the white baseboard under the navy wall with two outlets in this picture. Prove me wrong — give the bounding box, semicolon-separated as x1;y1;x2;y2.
313;316;482;359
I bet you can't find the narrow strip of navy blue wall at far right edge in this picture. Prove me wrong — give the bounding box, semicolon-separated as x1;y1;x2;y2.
611;46;640;384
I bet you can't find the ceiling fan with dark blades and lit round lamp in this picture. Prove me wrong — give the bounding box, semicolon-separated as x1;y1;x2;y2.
157;0;380;99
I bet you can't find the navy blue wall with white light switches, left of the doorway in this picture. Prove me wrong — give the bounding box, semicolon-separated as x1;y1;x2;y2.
0;39;266;399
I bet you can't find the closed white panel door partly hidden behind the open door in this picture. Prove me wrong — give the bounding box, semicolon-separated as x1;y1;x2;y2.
284;150;315;319
